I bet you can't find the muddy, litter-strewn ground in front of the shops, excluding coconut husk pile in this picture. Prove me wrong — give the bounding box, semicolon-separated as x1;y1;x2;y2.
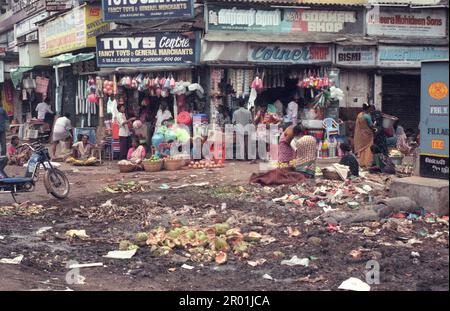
0;162;449;291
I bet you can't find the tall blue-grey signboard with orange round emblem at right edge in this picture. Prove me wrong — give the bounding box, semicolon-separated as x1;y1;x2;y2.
420;60;449;179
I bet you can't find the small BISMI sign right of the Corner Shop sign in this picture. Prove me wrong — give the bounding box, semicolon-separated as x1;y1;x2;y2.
336;45;376;66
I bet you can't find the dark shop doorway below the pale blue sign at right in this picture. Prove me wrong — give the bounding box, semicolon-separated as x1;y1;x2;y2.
382;75;420;133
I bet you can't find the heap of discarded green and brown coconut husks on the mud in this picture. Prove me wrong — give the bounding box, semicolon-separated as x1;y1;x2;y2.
119;222;262;264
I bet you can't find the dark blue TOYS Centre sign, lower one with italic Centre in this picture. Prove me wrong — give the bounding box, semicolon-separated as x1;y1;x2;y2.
97;33;199;67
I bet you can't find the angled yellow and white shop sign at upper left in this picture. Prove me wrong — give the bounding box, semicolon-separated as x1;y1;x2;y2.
39;5;109;57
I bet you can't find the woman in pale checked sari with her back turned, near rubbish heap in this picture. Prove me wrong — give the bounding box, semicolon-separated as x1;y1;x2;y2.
291;130;317;178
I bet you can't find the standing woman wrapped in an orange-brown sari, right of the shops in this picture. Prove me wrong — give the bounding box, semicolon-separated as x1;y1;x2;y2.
354;104;373;168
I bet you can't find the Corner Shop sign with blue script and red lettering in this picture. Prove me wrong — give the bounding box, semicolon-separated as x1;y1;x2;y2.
248;45;332;64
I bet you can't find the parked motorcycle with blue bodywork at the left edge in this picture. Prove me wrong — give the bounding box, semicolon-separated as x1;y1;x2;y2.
0;142;70;203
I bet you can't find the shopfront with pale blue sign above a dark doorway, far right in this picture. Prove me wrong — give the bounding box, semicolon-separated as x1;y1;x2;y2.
377;45;449;133
